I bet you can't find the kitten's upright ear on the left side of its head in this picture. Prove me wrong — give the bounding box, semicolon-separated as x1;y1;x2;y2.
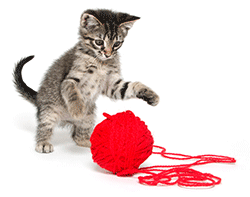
81;13;102;30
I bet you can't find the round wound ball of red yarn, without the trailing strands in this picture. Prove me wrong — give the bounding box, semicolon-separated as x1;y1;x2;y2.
90;111;154;176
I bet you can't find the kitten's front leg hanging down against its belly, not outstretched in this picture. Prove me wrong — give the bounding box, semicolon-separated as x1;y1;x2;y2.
61;79;86;119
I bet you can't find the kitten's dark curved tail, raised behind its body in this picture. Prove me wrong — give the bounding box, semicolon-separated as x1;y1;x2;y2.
13;55;37;105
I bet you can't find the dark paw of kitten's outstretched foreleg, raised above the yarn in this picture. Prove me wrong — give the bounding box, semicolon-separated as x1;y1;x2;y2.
136;88;160;106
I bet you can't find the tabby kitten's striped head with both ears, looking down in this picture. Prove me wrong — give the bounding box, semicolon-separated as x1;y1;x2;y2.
80;10;140;61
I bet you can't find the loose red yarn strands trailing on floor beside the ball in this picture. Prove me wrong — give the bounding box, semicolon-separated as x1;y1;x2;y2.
137;145;236;187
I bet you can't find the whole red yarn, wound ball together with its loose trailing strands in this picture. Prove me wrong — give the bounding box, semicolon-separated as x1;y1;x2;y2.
90;111;236;187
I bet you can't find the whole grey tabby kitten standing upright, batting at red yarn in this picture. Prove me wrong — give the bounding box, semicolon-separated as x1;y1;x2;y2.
13;10;159;153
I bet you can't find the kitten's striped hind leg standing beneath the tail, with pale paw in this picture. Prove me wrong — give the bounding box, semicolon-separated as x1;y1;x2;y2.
36;106;59;153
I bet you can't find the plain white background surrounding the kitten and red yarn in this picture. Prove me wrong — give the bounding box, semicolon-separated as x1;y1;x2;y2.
0;0;250;197
